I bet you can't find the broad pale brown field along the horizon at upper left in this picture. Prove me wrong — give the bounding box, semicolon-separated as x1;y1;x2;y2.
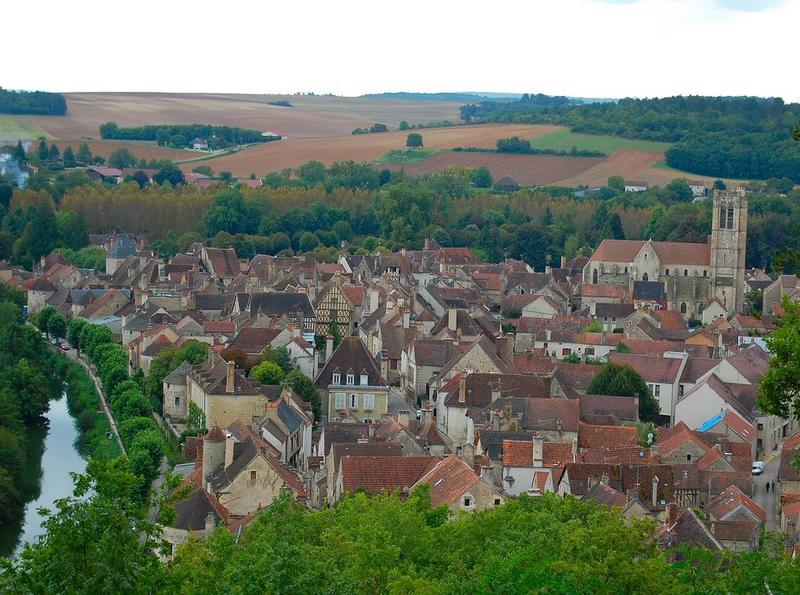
32;93;460;140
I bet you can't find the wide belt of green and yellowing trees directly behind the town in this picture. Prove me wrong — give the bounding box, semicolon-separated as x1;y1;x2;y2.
0;162;800;272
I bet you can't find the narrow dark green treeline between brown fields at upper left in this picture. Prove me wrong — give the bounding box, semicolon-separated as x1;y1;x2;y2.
100;122;281;149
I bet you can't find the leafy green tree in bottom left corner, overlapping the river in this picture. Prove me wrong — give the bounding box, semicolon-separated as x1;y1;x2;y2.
0;458;163;593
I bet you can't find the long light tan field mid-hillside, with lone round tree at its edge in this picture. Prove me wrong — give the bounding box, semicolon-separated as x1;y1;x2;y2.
188;122;572;176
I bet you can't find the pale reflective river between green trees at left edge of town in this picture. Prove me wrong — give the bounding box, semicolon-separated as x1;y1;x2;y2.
0;396;86;556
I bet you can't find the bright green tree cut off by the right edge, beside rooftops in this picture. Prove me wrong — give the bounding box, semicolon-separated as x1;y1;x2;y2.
751;297;800;418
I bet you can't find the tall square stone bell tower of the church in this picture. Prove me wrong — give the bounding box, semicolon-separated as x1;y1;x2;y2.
709;186;747;312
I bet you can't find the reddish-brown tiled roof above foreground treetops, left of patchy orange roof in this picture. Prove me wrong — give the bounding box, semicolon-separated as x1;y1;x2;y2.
340;456;441;493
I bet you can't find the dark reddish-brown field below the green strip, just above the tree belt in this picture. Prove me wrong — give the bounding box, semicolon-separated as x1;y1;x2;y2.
385;151;602;186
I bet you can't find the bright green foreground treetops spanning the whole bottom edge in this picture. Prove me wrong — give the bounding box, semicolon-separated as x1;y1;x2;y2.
0;478;800;594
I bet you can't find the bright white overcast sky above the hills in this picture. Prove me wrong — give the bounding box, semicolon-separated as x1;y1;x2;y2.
6;0;800;101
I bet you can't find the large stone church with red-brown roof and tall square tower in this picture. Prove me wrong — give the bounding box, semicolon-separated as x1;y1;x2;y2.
583;187;747;320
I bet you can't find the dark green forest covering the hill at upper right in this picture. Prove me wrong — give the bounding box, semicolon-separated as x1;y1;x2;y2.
461;96;800;183
